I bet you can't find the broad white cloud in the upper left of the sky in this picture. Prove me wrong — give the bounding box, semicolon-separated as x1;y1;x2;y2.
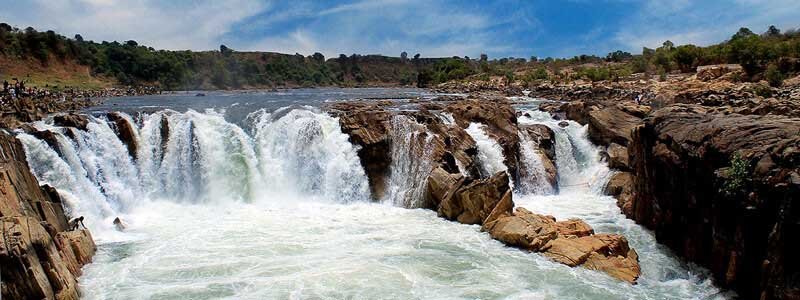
0;0;267;50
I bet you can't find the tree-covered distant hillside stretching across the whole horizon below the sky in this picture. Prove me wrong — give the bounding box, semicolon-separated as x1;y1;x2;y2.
0;23;800;90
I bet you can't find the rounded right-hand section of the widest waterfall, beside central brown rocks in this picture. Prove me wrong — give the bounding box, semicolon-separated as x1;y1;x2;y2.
248;107;369;202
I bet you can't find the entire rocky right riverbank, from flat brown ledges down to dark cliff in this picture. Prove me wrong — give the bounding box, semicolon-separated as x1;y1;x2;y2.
531;70;800;299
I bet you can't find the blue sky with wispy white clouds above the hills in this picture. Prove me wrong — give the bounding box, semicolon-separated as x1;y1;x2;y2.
0;0;800;58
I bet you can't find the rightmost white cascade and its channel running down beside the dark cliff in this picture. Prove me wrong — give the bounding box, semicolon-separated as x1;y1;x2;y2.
514;104;726;299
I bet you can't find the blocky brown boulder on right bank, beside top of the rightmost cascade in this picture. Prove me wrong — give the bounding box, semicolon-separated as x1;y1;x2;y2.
588;107;643;146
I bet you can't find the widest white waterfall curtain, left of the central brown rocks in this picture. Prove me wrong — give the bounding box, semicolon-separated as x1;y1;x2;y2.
18;108;369;232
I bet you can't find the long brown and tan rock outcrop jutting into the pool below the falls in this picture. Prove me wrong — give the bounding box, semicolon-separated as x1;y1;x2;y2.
428;168;641;283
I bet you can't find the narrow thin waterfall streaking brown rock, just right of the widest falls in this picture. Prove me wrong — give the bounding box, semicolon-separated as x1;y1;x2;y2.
384;115;433;208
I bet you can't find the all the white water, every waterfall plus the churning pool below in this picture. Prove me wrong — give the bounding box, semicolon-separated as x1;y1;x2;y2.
18;92;725;299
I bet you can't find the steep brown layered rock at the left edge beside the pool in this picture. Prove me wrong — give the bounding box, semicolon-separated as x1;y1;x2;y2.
0;132;95;299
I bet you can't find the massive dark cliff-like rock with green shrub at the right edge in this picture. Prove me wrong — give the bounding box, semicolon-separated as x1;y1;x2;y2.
620;104;800;299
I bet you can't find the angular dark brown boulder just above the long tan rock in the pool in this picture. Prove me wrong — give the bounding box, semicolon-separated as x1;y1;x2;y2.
438;171;509;224
